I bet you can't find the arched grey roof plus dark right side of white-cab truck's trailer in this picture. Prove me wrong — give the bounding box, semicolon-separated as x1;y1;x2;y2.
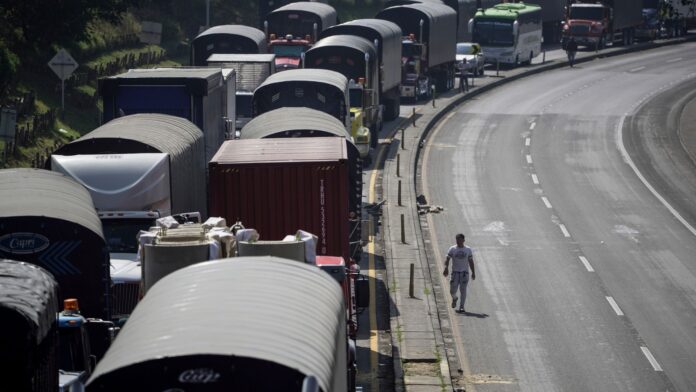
54;114;207;217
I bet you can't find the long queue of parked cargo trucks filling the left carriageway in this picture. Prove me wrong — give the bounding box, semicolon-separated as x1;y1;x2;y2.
0;0;692;391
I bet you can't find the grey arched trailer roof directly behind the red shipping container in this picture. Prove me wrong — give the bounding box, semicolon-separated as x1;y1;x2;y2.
241;107;353;140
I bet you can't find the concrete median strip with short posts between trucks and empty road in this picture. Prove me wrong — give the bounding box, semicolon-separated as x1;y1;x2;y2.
376;36;696;391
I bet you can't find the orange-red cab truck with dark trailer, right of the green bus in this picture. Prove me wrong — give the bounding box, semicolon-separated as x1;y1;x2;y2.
563;0;643;49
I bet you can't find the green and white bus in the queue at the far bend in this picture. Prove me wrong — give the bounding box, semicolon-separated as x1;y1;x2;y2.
469;3;542;65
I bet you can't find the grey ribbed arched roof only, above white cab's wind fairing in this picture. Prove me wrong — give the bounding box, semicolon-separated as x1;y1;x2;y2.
53;113;203;155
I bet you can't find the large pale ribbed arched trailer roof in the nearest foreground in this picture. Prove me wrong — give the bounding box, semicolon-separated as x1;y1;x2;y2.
87;256;346;392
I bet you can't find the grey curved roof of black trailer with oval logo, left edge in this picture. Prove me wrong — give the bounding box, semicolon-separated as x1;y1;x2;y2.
0;168;104;237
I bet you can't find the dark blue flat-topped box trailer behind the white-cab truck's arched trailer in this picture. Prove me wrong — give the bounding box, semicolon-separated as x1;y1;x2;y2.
99;68;236;160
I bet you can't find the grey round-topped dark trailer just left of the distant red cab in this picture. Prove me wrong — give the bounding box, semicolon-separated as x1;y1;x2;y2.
190;25;268;66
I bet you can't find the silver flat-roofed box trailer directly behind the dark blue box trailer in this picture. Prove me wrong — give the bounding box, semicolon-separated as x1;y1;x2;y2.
207;54;276;132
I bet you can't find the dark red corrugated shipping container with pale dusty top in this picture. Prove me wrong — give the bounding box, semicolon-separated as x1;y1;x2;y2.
208;137;350;260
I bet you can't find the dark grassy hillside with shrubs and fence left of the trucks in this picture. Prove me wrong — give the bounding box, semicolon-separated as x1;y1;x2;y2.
0;0;381;167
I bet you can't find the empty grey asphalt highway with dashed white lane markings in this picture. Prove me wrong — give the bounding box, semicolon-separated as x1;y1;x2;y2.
422;43;696;391
